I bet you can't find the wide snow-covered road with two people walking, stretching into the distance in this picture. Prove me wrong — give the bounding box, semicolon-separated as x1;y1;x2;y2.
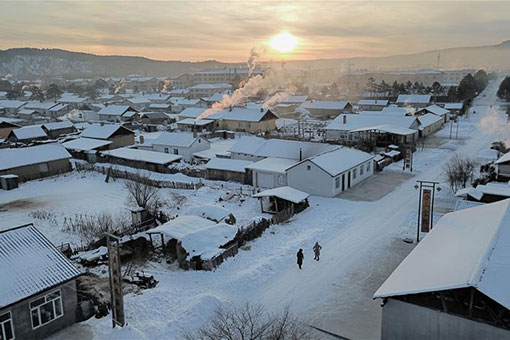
252;78;502;339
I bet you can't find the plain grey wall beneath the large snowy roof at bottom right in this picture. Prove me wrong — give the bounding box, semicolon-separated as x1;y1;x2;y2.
381;299;510;340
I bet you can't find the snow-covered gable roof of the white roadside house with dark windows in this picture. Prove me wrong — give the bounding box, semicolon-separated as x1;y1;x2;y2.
294;147;374;176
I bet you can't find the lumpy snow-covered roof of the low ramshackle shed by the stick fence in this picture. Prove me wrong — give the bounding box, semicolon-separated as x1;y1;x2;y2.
148;215;237;260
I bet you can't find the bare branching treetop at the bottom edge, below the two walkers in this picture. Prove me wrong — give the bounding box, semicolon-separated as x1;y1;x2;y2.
185;303;317;340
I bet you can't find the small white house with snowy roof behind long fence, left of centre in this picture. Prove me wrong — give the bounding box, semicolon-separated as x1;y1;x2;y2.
152;132;211;162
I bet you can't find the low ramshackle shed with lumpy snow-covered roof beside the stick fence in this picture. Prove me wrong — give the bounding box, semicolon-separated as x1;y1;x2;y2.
147;215;237;270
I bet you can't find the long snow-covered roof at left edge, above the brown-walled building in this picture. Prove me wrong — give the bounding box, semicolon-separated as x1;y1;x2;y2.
0;143;71;170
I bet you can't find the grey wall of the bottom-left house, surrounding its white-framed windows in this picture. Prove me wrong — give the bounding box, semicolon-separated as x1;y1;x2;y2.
0;280;78;340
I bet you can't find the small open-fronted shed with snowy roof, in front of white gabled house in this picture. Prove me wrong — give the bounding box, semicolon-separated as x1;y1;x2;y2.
253;187;310;214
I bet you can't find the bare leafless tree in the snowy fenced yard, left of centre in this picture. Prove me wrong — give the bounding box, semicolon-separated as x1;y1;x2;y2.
124;172;163;216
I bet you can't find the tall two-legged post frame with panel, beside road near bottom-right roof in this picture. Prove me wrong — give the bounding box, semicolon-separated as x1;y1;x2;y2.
414;180;441;243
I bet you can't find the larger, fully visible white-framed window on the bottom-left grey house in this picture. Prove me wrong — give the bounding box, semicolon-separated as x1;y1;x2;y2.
30;290;64;329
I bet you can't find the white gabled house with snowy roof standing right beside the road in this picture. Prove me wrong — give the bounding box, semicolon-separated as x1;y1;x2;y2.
287;147;374;197
